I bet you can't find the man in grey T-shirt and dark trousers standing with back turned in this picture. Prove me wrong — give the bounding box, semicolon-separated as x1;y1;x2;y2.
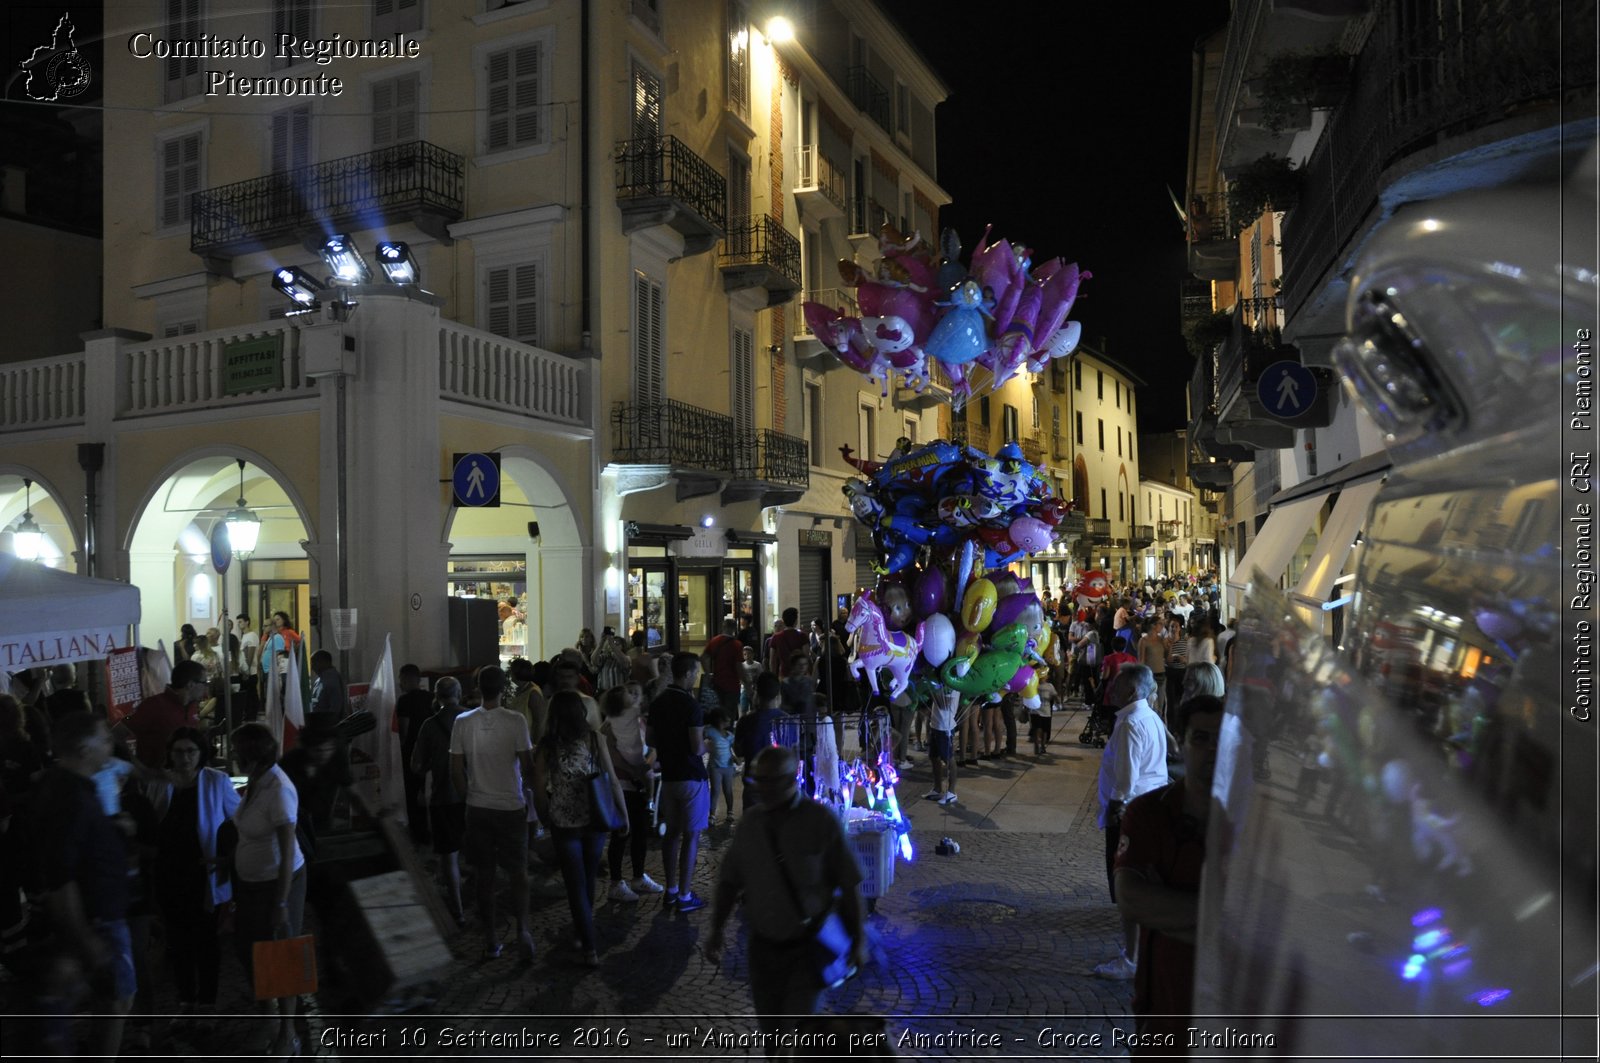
450;664;533;964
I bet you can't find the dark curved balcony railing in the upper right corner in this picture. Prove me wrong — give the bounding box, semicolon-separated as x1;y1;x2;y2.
1283;0;1595;319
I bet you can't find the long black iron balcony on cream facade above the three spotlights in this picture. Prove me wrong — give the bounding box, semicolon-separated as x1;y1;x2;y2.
189;141;466;259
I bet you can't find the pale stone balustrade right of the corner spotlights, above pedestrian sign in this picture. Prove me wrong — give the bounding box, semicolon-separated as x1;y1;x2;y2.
438;322;589;424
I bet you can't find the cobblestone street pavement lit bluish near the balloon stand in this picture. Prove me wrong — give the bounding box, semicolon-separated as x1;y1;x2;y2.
25;704;1158;1058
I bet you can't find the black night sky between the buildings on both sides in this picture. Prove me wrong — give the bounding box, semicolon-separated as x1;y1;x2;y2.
880;0;1227;432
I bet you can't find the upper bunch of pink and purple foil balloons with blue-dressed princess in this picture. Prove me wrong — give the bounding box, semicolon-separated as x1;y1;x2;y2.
802;224;1091;408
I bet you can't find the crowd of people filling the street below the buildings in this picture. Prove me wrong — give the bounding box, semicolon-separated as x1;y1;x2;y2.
0;576;1227;1055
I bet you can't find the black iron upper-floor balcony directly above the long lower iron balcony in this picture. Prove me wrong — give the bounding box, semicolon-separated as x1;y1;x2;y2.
616;136;729;256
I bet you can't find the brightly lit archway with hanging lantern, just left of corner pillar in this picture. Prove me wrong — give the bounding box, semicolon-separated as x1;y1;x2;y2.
125;448;315;656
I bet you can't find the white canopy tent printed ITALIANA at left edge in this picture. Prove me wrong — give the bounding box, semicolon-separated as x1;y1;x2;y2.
0;552;139;672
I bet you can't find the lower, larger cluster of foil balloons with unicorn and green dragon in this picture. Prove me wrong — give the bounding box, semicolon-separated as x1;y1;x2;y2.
845;440;1067;706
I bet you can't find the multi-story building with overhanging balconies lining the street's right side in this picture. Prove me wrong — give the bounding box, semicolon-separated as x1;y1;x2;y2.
1184;0;1595;626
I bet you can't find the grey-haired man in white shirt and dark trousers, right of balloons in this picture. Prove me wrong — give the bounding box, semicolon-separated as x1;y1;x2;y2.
1094;664;1168;981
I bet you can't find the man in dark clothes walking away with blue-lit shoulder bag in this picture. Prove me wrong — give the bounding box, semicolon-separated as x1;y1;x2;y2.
702;746;870;1033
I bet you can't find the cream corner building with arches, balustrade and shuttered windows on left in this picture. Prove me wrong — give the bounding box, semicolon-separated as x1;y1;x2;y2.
0;0;947;669
